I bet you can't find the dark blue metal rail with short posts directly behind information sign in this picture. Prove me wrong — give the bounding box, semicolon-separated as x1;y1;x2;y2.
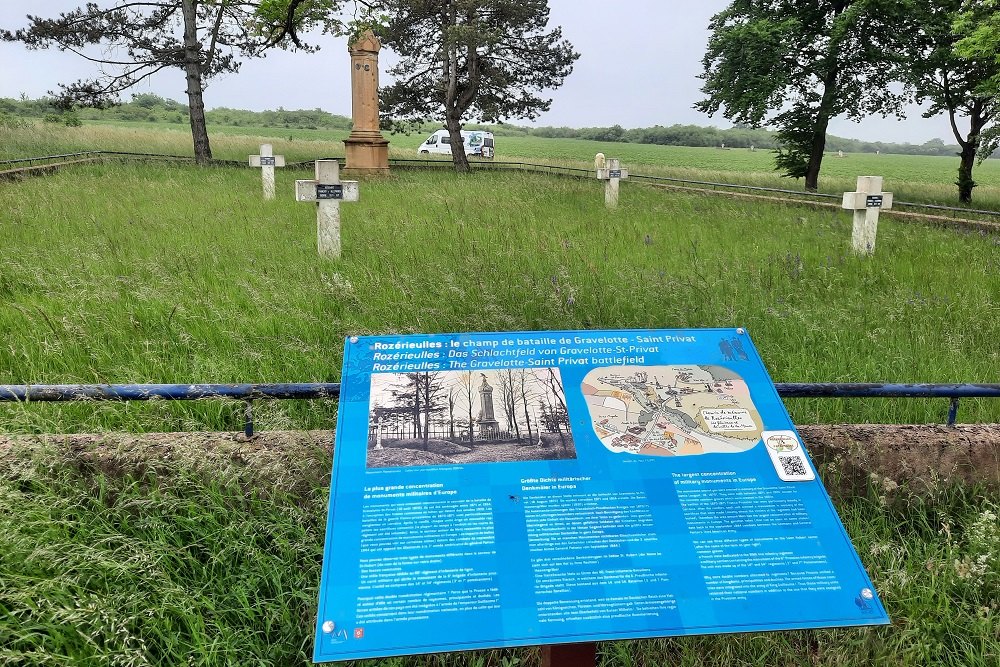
0;382;1000;437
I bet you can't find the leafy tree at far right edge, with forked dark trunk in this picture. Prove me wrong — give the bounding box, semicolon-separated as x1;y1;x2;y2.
904;0;1000;204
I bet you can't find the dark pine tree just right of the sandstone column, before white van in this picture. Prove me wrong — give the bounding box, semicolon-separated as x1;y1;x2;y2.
379;0;579;172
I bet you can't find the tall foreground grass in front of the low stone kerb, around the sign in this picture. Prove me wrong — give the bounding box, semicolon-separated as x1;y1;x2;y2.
0;440;1000;667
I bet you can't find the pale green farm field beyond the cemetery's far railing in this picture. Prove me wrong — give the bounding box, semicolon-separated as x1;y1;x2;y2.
0;122;1000;210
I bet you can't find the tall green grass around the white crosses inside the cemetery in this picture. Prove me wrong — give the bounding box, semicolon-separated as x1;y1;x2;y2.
0;164;1000;432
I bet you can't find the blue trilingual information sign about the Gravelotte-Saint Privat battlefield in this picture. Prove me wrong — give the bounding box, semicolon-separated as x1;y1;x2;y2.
314;329;888;662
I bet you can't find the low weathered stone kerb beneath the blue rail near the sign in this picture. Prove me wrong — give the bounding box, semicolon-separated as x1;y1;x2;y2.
0;424;1000;491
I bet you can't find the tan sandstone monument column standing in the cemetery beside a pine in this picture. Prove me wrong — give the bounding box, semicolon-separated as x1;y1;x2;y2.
344;30;389;174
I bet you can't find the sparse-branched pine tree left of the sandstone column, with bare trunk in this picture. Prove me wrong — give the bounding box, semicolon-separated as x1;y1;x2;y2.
0;0;329;163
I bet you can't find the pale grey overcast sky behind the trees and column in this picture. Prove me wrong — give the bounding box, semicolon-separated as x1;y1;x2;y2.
0;0;955;143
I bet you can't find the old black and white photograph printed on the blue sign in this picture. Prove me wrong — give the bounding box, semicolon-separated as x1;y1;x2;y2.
367;368;576;468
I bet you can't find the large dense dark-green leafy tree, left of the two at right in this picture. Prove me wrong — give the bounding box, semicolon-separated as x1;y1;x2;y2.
695;0;904;190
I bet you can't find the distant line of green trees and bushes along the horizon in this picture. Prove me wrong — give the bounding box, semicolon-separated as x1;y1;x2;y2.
0;93;959;156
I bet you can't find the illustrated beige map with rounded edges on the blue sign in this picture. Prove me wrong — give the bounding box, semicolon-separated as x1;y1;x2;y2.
582;365;764;456
